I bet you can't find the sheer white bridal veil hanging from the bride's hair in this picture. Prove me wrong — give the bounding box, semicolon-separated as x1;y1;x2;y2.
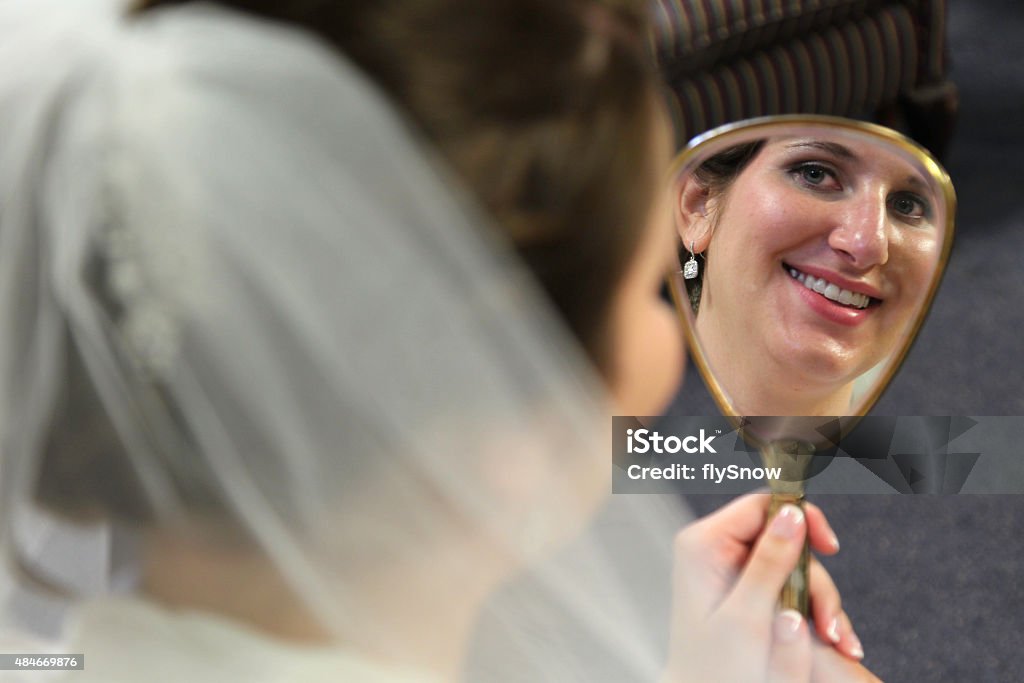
0;0;692;681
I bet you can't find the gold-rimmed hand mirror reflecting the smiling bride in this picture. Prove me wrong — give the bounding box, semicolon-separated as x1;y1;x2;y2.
671;116;955;613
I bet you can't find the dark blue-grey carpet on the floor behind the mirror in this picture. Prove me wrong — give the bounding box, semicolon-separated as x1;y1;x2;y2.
689;0;1024;683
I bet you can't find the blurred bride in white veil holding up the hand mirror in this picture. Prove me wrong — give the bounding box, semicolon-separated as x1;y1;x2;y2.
0;0;872;683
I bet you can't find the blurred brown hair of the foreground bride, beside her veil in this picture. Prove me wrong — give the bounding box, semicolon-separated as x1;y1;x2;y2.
39;0;662;521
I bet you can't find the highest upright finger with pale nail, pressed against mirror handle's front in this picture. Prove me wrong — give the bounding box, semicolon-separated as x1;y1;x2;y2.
726;504;807;614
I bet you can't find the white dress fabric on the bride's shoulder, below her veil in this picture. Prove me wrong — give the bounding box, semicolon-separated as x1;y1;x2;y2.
0;598;439;683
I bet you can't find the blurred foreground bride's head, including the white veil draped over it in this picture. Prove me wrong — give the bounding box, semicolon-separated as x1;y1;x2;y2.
0;0;682;671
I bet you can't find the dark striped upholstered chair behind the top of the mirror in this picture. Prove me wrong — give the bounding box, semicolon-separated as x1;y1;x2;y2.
651;0;956;156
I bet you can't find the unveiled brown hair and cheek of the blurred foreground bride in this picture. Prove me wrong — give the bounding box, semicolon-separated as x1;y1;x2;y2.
134;0;683;415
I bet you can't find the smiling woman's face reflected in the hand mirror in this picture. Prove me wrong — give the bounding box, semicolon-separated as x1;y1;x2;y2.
681;134;944;415
